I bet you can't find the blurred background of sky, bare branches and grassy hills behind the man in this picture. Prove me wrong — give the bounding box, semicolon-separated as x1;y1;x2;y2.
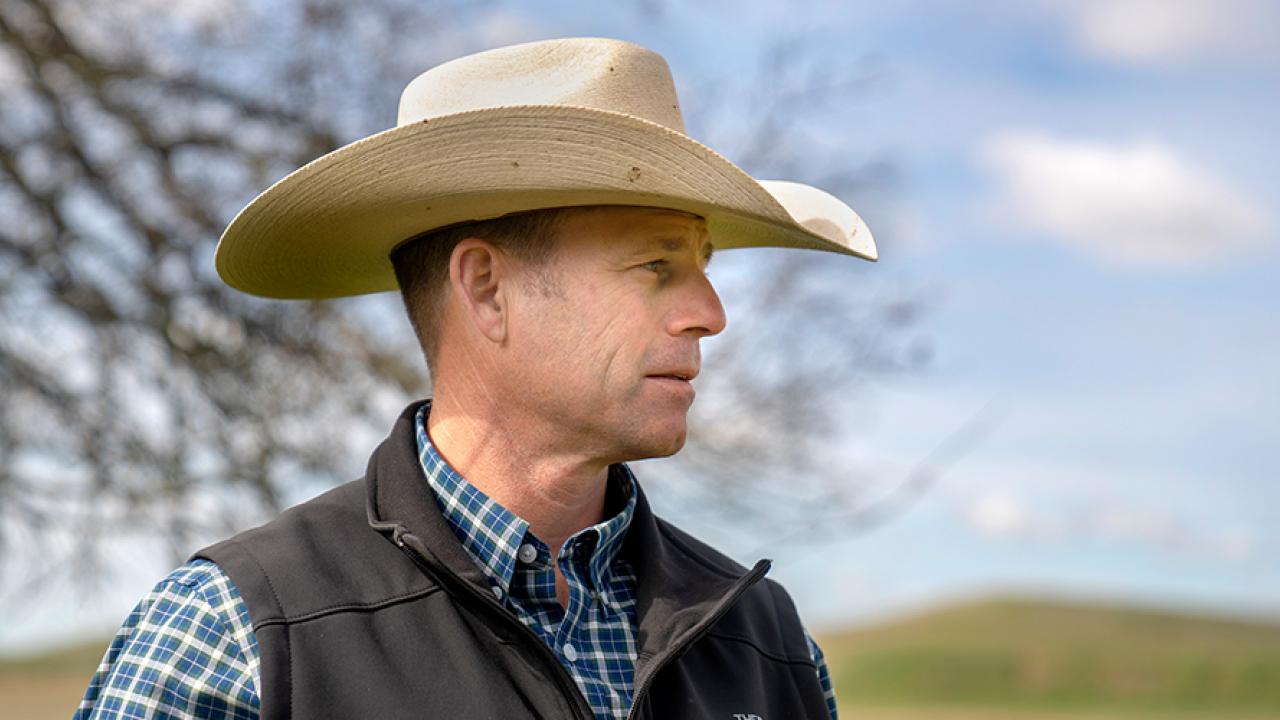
0;0;1280;720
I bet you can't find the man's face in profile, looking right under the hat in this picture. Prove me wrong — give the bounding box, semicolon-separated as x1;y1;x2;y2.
504;206;724;462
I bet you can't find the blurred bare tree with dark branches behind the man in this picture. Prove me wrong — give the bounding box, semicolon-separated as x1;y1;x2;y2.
0;0;923;594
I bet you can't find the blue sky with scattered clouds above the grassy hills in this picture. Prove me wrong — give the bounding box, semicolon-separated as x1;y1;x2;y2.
0;0;1280;651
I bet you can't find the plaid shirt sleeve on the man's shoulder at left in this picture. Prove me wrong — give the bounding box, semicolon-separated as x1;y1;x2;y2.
73;560;260;720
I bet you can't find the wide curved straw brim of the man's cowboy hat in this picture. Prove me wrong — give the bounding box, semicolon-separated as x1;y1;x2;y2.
215;105;877;299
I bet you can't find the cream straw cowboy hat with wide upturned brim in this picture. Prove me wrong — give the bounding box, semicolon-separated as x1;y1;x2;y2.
215;38;876;299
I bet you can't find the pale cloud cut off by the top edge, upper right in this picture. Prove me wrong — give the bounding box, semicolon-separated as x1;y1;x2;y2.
1055;0;1275;64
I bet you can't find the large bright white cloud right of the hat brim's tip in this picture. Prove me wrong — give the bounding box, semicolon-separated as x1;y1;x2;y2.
980;131;1270;266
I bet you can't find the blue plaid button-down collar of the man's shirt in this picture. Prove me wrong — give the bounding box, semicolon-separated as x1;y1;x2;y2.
415;401;636;592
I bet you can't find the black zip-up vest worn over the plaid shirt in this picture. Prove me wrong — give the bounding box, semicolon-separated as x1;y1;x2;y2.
196;404;828;720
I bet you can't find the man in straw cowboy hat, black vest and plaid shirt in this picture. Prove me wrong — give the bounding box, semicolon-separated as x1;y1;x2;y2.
79;38;874;720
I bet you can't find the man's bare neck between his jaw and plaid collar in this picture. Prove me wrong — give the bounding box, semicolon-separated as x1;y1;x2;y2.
428;388;608;555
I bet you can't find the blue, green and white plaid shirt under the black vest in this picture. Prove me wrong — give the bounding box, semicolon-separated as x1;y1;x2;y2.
74;406;836;720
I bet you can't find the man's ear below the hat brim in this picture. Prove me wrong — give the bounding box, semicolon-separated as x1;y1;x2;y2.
449;237;511;343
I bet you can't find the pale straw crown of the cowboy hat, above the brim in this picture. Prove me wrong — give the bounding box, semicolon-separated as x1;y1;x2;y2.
396;37;685;133
